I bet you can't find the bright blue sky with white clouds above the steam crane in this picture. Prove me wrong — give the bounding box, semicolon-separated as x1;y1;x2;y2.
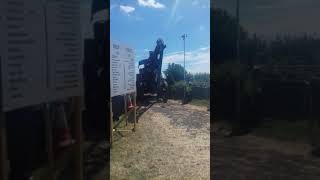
110;0;210;73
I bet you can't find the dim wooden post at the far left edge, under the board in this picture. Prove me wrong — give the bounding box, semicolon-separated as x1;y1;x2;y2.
0;112;9;180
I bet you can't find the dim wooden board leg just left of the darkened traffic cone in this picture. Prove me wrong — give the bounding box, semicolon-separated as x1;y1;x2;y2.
43;104;55;180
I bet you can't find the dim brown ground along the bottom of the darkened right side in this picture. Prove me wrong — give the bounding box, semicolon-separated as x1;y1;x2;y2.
211;121;320;180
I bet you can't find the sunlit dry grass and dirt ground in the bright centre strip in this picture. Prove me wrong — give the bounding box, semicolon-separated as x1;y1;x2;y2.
104;100;210;180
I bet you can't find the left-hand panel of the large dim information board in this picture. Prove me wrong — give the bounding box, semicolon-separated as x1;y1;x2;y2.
0;0;46;111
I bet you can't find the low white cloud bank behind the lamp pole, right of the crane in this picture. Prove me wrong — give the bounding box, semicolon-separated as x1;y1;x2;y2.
162;46;210;73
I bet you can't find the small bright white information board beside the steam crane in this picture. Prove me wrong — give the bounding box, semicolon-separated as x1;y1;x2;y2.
110;41;136;97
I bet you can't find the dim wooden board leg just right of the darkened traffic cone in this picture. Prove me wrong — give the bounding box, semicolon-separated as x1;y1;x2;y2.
71;96;83;180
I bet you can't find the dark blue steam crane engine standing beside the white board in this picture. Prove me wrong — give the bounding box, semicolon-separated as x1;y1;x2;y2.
136;39;167;100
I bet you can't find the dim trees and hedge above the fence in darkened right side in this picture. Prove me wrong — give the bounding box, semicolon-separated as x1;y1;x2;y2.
212;9;320;65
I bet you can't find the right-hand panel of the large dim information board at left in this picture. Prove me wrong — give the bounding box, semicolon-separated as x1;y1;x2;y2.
46;0;83;100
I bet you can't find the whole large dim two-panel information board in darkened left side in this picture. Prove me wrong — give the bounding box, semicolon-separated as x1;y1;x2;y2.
0;0;83;111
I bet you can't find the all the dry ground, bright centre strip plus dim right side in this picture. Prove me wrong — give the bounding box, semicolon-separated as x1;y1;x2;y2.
85;98;320;180
